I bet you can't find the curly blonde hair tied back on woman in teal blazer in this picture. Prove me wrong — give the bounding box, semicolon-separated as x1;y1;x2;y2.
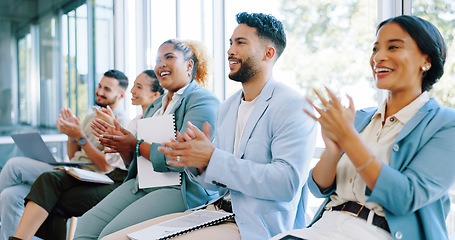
163;39;211;86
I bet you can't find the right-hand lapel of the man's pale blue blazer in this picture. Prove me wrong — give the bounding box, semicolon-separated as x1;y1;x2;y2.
234;78;277;158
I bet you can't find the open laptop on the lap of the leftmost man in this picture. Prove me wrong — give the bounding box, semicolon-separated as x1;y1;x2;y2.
11;132;89;166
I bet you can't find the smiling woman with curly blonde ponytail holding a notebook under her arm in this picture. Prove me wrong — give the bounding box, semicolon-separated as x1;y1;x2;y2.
75;40;219;239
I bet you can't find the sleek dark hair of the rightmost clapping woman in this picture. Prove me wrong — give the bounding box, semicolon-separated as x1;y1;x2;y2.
376;15;447;91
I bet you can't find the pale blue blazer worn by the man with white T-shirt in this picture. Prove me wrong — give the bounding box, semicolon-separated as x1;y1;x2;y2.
188;79;316;240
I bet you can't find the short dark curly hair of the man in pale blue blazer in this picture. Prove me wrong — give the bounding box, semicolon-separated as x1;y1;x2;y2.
235;12;286;58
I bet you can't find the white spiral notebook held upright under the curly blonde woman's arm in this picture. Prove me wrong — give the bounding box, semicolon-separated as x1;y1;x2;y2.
137;114;180;188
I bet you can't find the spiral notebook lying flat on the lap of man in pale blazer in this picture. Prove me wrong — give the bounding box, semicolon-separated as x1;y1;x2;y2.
127;210;234;240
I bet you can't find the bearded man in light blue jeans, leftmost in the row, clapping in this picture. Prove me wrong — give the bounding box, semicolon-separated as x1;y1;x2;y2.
0;70;128;240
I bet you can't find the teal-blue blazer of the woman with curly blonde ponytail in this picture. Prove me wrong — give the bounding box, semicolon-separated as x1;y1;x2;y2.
125;81;220;208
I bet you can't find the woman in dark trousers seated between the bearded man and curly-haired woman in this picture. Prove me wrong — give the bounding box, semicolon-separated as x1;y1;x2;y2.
11;70;164;239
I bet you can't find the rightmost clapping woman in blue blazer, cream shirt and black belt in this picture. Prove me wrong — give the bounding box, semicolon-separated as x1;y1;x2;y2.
277;16;455;240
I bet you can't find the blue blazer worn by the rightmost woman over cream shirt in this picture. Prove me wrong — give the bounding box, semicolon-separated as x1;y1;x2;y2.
308;99;455;240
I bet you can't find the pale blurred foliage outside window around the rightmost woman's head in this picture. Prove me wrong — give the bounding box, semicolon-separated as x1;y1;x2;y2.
280;0;455;107
